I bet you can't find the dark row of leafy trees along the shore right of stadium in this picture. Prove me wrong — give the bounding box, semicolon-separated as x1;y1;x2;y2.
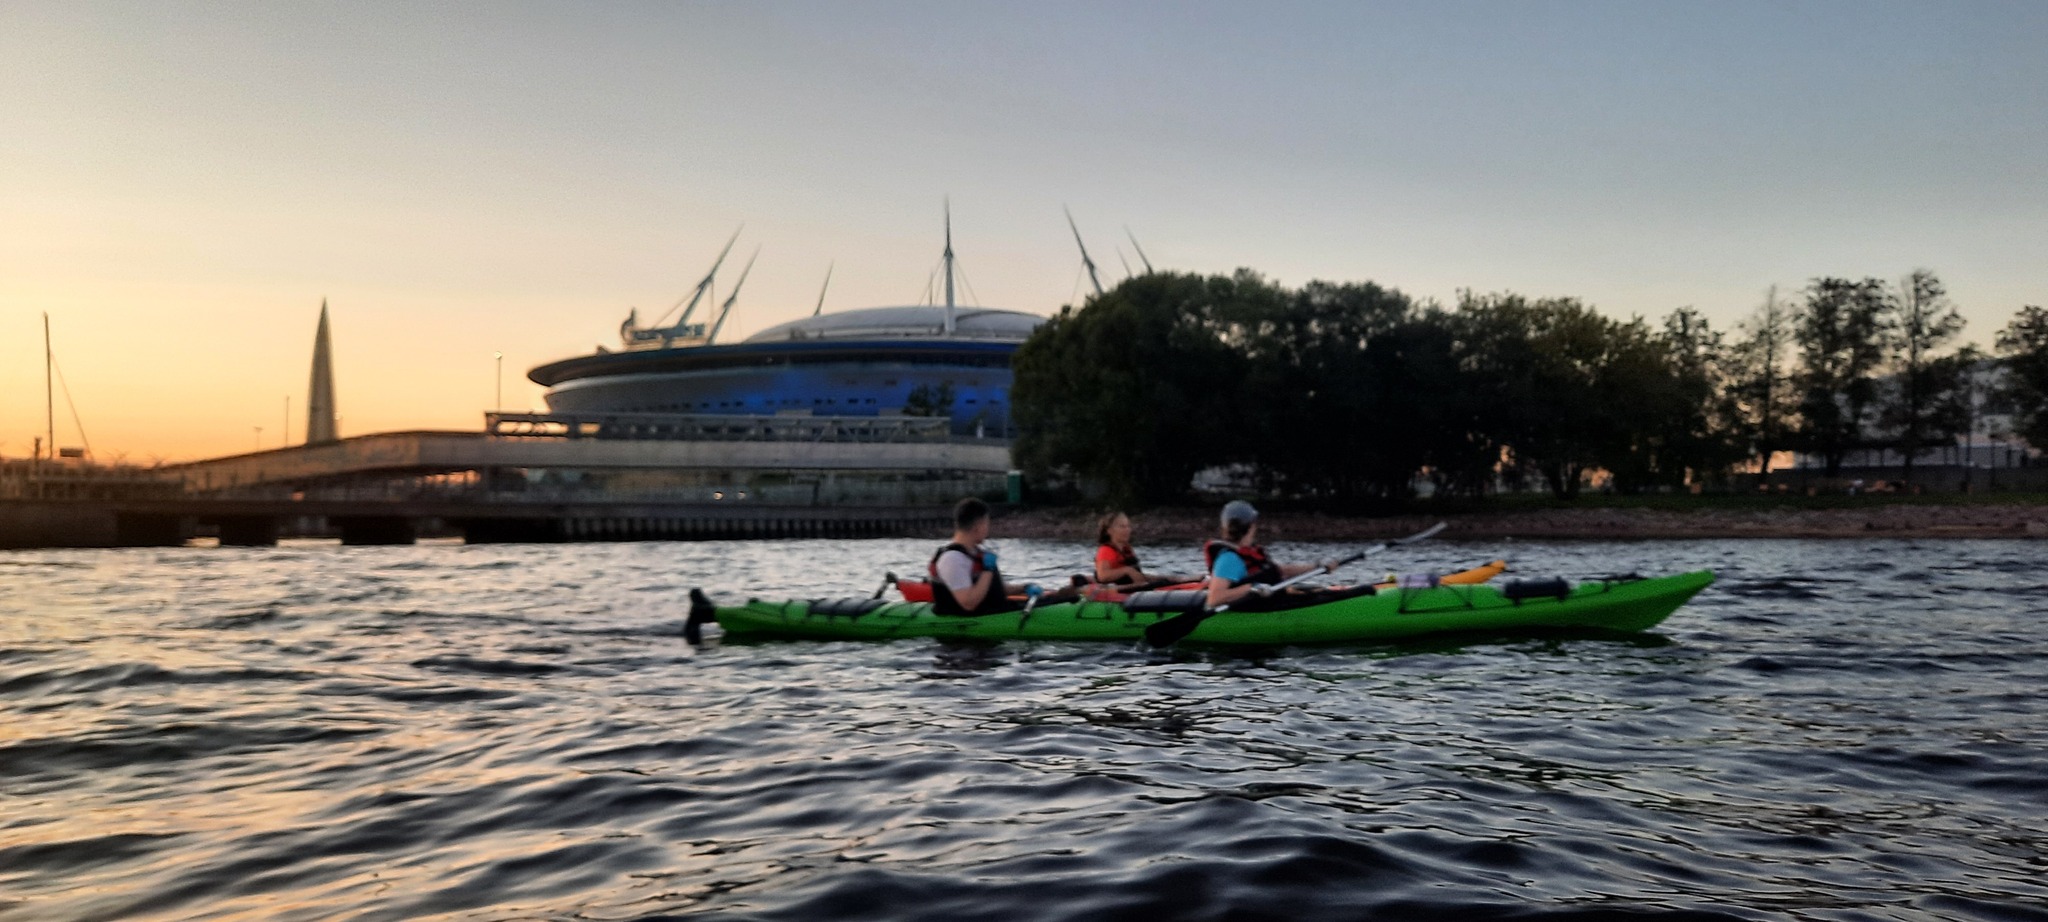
1012;270;2048;502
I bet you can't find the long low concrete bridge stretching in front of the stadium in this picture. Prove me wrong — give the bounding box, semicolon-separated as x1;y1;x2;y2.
0;414;1010;547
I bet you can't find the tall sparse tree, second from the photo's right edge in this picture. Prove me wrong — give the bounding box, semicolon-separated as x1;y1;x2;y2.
1878;268;1968;484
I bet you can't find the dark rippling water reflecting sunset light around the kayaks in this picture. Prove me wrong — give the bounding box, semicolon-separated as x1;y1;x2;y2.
0;541;2048;920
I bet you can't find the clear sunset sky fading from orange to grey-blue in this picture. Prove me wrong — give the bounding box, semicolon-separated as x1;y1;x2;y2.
0;0;2048;463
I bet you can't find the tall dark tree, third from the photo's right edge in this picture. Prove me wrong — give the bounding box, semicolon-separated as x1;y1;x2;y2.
1792;279;1892;477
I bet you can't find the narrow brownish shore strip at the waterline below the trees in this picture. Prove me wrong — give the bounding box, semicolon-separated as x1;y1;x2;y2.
995;504;2048;543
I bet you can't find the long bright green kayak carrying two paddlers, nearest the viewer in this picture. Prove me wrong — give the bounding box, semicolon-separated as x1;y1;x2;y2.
684;570;1714;645
